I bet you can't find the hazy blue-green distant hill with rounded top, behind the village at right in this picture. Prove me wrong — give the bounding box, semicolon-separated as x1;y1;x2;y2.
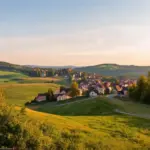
75;64;150;78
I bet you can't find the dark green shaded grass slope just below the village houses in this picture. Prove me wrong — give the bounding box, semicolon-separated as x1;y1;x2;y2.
38;97;117;116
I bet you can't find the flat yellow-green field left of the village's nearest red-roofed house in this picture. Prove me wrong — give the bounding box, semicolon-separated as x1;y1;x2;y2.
0;83;59;106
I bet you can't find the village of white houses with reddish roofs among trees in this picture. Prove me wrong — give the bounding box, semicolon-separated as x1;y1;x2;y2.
32;72;137;103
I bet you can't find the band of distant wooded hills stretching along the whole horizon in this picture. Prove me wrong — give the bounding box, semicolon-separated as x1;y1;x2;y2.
0;62;150;78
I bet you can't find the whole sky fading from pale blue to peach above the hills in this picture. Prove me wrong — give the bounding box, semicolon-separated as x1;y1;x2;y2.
0;0;150;66
